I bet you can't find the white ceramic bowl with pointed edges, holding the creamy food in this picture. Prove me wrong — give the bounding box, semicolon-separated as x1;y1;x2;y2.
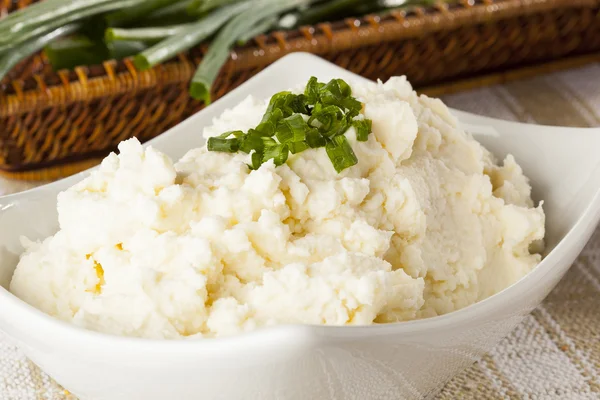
0;54;600;400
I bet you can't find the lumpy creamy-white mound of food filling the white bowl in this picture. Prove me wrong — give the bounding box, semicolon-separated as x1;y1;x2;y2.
10;77;544;339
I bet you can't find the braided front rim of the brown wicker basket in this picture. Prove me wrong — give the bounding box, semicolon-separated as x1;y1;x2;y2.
0;0;600;118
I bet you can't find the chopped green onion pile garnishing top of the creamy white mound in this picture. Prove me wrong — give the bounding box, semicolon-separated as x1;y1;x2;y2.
207;77;372;173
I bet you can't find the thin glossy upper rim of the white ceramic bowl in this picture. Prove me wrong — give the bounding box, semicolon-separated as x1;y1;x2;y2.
0;53;600;355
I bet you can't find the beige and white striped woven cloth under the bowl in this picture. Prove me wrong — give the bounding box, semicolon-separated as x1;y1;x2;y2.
0;64;600;400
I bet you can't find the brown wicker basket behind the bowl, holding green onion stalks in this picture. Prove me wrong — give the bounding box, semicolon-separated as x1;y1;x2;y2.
0;0;600;180
